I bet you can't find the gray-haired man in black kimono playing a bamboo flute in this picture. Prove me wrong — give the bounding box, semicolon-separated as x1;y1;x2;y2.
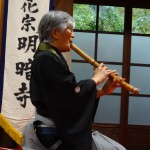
23;11;123;150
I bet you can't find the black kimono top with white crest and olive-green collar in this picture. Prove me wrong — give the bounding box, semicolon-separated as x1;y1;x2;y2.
30;43;98;150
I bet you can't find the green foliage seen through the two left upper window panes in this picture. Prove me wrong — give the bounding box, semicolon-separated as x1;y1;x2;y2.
73;4;124;32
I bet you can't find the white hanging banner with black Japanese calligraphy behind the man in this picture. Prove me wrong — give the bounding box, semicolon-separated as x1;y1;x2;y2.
1;0;50;132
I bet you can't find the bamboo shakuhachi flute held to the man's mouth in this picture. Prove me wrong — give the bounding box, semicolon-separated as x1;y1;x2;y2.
70;43;139;95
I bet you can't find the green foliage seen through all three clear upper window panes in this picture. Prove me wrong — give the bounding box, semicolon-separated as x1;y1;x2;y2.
73;4;150;34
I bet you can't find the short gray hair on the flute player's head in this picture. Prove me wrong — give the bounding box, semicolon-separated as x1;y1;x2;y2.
38;10;74;42
